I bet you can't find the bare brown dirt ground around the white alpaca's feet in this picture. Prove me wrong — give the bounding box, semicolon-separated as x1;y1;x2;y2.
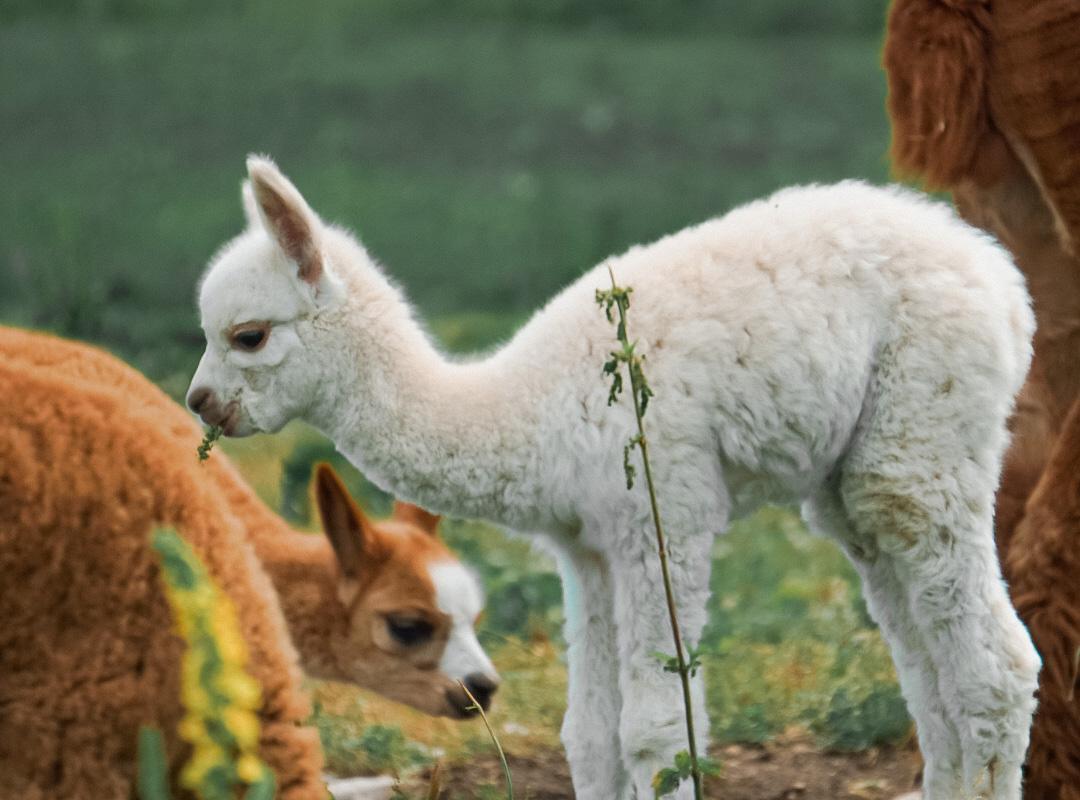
407;738;918;800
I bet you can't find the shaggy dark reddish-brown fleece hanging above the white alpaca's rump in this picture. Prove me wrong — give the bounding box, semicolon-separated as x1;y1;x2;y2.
882;0;1080;249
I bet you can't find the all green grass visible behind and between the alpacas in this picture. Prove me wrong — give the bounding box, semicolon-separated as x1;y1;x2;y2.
0;0;908;771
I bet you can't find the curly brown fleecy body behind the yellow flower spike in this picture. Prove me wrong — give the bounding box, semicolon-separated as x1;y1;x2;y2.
0;355;325;800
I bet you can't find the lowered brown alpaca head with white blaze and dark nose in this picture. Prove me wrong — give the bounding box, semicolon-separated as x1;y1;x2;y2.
315;464;499;717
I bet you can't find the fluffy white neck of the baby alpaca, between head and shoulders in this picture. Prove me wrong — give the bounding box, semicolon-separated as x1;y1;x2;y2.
308;259;537;527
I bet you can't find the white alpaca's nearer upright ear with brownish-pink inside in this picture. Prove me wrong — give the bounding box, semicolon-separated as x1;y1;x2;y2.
247;155;323;286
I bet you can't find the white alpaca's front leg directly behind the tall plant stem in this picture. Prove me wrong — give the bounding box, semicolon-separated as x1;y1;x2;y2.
611;519;712;800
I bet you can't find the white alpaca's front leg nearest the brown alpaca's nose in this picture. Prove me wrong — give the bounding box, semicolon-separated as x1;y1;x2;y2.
558;539;629;800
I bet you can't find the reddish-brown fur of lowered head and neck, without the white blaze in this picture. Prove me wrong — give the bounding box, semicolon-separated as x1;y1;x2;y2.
282;465;481;716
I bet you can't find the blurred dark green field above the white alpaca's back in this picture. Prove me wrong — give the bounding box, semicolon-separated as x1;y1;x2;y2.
0;0;887;392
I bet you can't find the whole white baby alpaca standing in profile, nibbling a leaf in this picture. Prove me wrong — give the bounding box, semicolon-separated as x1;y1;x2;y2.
189;158;1039;800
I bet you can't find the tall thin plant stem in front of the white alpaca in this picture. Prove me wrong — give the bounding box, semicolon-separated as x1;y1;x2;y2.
608;266;705;800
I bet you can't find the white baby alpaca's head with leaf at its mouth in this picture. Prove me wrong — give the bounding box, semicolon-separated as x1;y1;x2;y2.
188;157;346;436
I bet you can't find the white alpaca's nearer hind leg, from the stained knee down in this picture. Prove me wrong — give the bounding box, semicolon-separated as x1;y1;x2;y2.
846;467;1039;800
